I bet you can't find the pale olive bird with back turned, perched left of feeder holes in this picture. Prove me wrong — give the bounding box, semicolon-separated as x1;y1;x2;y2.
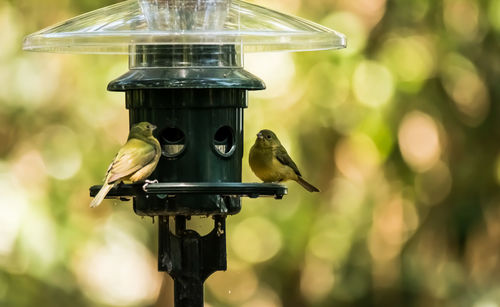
90;122;161;208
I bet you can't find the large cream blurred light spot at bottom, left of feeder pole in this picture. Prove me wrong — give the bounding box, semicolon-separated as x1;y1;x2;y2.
74;236;162;306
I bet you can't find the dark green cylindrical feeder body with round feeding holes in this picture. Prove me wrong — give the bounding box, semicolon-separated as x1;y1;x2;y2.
108;45;265;216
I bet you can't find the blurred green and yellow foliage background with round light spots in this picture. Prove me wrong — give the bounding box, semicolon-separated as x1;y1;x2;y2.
0;0;500;307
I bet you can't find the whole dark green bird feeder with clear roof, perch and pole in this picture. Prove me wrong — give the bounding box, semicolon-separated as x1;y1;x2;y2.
24;0;346;307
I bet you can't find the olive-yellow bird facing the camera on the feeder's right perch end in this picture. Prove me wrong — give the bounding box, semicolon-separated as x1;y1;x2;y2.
248;129;319;192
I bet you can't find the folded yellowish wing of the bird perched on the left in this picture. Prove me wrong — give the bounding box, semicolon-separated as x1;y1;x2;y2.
106;138;156;183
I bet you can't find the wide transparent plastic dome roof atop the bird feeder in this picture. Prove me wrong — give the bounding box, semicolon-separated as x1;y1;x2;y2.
23;0;346;54
